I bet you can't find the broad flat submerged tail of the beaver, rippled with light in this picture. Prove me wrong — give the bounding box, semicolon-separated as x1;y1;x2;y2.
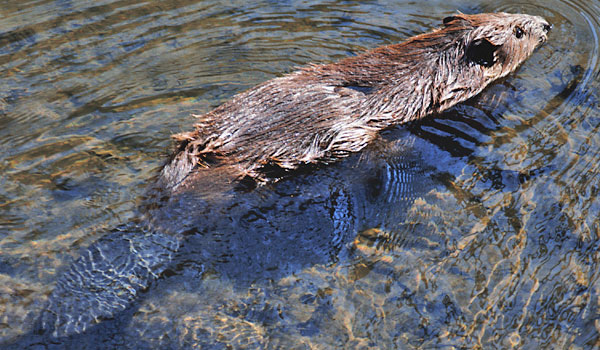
35;223;180;337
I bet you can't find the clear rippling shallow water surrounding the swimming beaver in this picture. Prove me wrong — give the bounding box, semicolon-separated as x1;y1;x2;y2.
0;1;600;349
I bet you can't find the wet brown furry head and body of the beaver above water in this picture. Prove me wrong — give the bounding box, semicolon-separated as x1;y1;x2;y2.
159;13;550;190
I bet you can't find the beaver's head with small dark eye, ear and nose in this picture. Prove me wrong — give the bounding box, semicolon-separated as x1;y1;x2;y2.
443;13;552;80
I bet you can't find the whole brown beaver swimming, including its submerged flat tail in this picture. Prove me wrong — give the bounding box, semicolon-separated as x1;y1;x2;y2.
37;13;551;336
